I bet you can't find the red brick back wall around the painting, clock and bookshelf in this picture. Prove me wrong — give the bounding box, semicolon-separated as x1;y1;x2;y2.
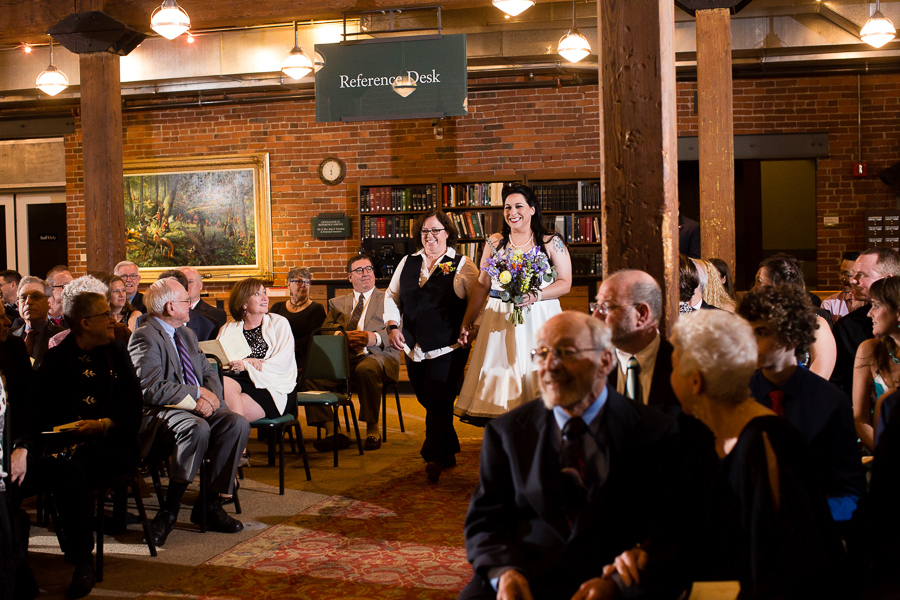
66;76;900;291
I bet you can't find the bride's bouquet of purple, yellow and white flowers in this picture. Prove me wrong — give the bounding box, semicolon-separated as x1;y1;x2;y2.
484;246;556;325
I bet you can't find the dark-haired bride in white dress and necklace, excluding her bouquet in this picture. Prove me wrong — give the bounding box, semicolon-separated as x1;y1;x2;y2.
454;183;572;425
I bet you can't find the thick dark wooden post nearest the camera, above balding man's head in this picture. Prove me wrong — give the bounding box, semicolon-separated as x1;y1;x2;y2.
597;0;678;323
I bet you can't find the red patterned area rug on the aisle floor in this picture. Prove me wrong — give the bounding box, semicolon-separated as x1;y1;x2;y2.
141;441;480;600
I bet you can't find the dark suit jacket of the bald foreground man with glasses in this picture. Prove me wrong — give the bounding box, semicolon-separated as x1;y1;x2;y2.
465;387;680;598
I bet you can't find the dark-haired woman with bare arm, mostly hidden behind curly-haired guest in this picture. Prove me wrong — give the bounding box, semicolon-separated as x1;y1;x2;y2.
754;254;837;379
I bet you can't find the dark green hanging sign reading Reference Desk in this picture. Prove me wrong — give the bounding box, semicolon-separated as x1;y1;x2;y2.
316;35;468;123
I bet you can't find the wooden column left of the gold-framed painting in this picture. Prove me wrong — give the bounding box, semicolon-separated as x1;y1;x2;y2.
79;52;125;273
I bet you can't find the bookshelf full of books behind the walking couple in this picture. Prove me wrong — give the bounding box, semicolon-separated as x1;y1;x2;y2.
359;173;602;279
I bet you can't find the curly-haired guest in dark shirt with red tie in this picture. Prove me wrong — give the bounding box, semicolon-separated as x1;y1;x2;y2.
738;286;866;521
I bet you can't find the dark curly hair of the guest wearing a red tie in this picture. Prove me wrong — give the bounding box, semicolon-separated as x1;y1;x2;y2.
738;285;819;358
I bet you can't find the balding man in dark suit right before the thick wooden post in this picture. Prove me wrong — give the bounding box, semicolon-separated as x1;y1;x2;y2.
592;270;679;414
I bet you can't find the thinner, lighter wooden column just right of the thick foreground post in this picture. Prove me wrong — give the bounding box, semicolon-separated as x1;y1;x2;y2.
696;8;736;273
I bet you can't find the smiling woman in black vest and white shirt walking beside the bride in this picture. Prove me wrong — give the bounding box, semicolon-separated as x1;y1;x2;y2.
384;210;486;482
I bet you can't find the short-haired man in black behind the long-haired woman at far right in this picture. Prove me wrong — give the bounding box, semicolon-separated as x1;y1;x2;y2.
830;248;900;396
